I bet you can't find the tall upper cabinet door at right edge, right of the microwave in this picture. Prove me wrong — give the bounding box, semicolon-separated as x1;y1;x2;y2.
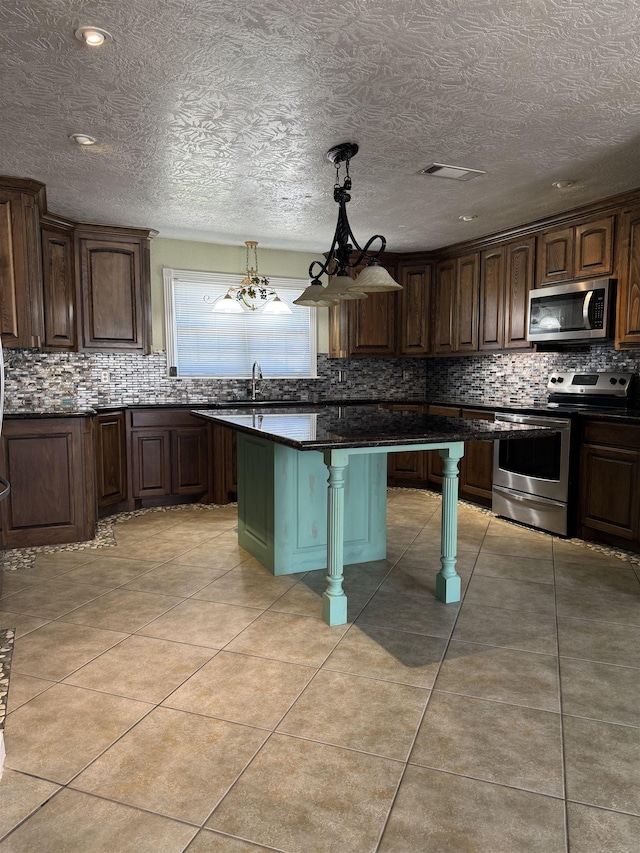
616;208;640;349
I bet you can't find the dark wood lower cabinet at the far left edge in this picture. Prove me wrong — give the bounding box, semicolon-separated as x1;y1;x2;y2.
0;417;95;548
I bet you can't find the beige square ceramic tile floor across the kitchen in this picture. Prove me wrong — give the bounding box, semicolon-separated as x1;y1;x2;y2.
0;490;640;853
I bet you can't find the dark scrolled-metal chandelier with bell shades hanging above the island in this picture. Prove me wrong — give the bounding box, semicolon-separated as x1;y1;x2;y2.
294;142;402;308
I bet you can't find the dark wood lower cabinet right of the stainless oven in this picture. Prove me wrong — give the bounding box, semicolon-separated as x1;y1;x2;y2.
578;421;640;551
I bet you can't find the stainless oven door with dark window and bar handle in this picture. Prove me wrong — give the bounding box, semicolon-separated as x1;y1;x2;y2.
493;412;571;502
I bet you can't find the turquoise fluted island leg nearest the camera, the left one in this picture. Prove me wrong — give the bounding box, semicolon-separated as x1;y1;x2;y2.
322;450;349;625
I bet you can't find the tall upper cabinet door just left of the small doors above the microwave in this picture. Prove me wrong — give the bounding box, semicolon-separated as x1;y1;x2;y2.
504;237;535;349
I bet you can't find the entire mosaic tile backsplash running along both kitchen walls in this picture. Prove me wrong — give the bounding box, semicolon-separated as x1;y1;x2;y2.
5;345;640;414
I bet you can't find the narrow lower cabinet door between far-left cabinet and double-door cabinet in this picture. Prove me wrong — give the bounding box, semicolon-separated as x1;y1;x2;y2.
94;412;127;510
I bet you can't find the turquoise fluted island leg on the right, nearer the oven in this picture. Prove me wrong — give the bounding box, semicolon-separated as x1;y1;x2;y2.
436;443;464;604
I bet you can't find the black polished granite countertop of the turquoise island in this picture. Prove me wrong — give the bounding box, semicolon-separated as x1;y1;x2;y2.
193;403;553;450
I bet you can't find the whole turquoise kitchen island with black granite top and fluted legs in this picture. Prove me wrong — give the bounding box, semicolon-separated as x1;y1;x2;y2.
192;404;553;625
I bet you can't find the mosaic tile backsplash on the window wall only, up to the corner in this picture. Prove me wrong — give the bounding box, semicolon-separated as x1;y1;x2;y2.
5;350;426;414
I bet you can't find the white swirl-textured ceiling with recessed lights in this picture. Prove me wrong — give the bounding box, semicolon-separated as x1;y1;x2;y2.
0;0;640;251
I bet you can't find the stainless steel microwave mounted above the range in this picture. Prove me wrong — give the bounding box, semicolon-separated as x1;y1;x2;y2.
527;278;615;343
